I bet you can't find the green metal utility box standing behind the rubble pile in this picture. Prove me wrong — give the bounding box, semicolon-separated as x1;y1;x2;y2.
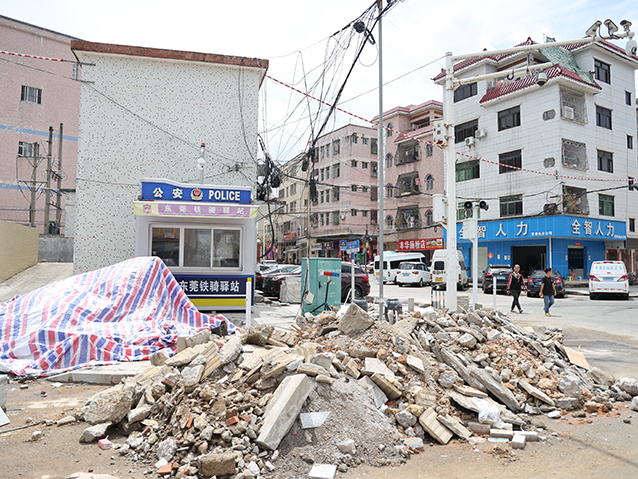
301;258;341;315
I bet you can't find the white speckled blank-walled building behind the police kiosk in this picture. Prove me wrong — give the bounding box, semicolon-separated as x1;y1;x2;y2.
71;41;268;273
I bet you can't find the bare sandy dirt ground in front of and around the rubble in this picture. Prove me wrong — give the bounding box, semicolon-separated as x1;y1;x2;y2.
0;379;638;479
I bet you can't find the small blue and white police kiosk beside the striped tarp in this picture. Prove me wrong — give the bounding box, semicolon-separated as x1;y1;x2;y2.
134;179;258;310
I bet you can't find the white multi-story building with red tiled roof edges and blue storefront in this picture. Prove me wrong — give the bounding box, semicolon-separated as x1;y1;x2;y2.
434;39;638;278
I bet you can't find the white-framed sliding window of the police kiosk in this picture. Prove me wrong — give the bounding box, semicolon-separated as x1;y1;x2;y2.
150;225;242;270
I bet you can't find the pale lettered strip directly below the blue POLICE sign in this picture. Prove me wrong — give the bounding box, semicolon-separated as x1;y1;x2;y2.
133;201;259;219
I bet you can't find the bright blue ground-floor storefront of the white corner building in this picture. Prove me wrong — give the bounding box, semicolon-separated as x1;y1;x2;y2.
457;215;627;280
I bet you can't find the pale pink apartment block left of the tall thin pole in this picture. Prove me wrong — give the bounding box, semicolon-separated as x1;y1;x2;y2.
309;124;379;263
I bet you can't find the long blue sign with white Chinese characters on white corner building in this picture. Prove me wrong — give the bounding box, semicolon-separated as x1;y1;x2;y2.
457;215;627;241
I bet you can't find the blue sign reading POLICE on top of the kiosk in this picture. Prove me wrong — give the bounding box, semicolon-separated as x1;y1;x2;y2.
141;179;252;205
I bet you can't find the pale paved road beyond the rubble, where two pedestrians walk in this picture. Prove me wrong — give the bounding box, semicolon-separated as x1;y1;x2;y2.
370;282;638;378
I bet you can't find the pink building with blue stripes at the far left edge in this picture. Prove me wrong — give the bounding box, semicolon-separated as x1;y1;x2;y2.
0;15;80;236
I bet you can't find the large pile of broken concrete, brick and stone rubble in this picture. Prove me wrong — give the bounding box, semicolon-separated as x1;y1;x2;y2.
70;304;638;479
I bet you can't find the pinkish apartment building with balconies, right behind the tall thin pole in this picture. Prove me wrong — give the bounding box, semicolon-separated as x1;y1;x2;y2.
375;100;445;258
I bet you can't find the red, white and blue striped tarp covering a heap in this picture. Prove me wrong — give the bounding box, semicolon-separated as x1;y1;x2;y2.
0;257;237;376
